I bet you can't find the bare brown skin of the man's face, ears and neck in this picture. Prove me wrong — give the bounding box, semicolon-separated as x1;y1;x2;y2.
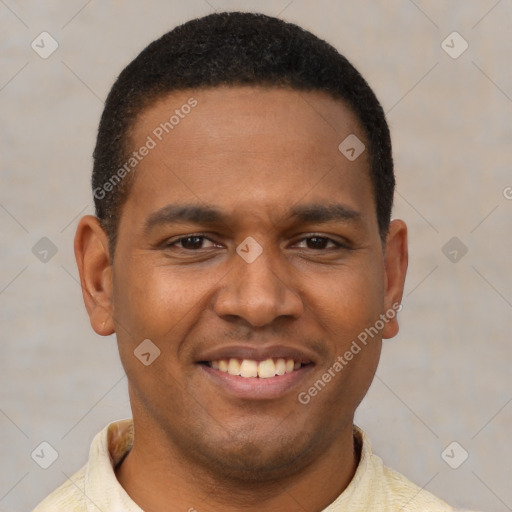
75;86;407;512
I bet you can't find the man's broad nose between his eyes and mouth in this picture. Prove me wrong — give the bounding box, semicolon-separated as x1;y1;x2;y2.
214;245;304;327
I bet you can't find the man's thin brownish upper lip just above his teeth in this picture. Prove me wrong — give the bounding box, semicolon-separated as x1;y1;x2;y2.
197;345;314;364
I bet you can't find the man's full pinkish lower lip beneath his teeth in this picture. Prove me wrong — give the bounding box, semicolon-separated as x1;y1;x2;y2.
199;364;313;400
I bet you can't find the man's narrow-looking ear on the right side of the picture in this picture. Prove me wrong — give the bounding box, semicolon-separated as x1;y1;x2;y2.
382;219;409;338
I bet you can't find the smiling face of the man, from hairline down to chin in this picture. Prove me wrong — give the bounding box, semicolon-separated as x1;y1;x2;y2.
76;87;405;478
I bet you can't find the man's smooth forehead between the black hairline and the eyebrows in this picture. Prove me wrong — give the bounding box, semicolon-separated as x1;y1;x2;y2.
122;86;373;228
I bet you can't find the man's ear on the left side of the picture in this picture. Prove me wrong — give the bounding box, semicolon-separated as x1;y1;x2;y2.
75;215;114;336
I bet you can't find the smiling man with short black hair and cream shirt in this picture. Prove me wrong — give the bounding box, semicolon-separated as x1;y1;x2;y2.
35;12;460;512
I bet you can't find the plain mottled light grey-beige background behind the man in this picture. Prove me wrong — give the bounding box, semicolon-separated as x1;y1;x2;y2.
0;0;512;512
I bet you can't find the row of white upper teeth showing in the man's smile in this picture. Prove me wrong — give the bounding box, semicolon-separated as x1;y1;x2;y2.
211;357;302;379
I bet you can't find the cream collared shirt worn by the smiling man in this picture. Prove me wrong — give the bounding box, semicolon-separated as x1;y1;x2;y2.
33;419;464;512
